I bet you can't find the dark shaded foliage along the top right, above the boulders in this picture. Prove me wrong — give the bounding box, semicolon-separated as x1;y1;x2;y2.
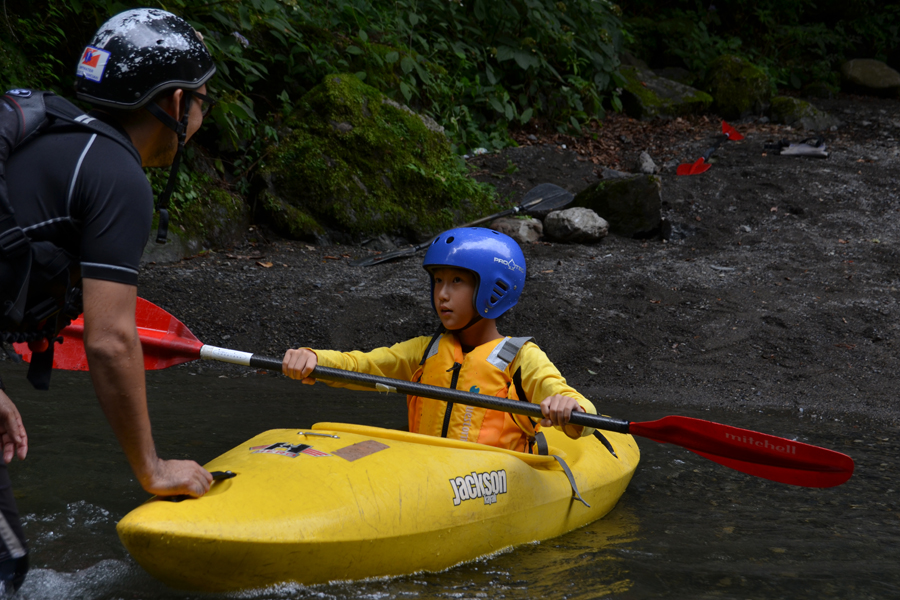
622;0;900;88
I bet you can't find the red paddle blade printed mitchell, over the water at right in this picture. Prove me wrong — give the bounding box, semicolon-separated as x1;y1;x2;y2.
628;416;853;487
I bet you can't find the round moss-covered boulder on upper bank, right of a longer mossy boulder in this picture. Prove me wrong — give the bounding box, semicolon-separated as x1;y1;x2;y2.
703;54;772;119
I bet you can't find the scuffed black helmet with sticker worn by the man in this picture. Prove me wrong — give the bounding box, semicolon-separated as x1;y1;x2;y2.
75;8;216;110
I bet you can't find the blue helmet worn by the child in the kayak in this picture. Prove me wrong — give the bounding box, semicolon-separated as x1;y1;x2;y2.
422;227;525;319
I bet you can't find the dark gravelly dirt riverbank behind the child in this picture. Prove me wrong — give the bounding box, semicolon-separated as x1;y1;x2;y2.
139;96;900;426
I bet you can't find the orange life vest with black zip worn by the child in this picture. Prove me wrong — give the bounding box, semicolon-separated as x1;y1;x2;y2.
407;333;540;452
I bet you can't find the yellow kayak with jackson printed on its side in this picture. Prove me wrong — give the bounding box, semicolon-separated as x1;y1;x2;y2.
117;423;640;592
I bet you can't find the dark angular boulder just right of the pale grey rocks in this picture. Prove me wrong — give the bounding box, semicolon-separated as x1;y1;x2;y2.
572;175;662;236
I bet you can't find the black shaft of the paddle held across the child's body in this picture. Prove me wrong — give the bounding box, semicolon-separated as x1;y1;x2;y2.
243;354;629;433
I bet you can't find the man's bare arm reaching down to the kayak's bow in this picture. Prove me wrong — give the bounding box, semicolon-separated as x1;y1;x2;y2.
84;279;212;497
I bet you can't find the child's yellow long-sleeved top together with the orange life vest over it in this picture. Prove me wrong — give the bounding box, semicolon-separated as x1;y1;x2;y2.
313;333;597;451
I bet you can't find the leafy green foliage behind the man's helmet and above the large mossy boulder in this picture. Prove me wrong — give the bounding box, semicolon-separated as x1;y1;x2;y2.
0;0;621;153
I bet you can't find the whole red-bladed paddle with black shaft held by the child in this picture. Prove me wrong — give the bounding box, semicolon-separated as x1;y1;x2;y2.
15;298;854;487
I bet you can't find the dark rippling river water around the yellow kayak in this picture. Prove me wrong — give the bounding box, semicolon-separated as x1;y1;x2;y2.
4;363;900;600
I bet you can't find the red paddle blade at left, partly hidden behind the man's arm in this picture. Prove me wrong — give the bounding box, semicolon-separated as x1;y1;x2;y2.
13;298;203;371
